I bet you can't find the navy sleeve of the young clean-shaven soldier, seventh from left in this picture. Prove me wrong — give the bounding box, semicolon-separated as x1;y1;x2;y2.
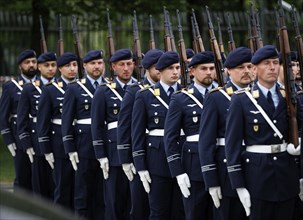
131;91;147;171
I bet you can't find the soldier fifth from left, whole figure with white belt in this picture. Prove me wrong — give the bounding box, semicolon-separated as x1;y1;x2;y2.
92;49;134;220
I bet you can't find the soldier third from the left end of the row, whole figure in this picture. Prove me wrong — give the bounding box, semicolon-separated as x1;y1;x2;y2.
37;53;78;210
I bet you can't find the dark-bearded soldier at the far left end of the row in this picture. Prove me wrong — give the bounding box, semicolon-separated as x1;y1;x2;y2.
0;50;37;191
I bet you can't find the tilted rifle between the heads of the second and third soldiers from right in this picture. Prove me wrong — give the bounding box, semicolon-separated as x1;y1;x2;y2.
205;6;224;86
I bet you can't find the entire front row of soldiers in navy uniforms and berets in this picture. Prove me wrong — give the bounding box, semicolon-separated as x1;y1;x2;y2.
0;46;303;219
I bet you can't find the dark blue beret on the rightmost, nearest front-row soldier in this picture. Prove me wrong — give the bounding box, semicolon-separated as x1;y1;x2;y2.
251;45;278;64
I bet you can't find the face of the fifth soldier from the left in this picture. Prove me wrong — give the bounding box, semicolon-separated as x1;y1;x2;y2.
112;59;135;83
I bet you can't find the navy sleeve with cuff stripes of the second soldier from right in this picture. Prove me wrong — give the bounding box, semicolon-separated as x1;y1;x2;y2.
198;94;219;189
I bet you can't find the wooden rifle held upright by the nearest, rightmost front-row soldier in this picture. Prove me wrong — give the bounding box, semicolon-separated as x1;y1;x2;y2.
279;0;299;147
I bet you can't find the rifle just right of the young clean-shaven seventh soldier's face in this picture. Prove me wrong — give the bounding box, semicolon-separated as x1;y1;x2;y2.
176;9;189;88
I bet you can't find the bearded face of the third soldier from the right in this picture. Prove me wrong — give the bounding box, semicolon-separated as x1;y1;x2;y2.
191;63;216;87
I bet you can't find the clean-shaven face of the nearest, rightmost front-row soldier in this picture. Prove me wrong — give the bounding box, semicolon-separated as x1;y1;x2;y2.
253;58;280;89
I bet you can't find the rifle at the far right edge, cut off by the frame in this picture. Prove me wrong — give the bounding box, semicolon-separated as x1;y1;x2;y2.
291;6;303;85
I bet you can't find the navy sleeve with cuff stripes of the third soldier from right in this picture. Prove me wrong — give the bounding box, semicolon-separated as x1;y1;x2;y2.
164;94;185;177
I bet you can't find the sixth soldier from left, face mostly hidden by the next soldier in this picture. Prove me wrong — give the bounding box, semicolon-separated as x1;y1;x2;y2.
117;49;164;220
